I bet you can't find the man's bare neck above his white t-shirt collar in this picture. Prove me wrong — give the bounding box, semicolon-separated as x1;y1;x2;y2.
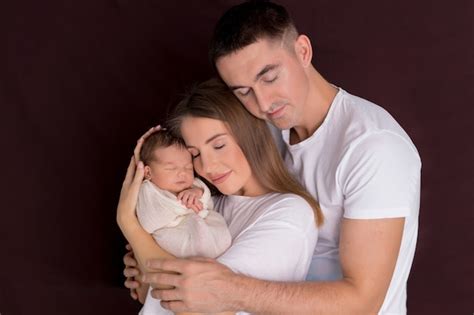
290;67;338;144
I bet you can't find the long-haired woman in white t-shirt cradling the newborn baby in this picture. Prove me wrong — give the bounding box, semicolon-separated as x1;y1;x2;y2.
117;79;323;313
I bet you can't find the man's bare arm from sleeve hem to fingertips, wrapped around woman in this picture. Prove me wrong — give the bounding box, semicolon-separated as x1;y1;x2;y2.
147;218;405;314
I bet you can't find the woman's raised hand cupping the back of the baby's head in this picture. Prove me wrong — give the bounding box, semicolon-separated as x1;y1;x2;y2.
117;157;144;228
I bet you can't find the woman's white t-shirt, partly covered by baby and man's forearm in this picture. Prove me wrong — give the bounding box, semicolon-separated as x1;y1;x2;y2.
140;193;318;315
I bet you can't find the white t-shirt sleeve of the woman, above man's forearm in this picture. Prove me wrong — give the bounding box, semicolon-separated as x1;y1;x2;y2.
217;198;317;281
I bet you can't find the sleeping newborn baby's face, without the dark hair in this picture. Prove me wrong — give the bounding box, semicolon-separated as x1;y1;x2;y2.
145;145;194;194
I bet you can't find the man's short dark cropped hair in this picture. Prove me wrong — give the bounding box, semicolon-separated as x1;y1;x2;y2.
209;0;297;65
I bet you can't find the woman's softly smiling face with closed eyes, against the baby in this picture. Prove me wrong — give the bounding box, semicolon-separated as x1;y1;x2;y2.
181;116;265;196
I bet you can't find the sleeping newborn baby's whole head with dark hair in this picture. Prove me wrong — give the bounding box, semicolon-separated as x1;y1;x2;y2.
140;130;194;194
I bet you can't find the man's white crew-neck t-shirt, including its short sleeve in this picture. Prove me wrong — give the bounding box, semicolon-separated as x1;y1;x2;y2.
273;89;421;314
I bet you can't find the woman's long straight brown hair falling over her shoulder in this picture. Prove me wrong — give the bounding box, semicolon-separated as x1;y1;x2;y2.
167;79;324;226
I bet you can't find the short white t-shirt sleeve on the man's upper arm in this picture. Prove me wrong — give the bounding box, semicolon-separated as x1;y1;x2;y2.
337;131;421;219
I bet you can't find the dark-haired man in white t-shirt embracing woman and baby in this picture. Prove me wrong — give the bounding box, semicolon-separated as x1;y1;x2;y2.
124;2;421;314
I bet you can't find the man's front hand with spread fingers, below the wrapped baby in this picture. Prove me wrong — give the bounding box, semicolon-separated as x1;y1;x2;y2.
142;258;239;313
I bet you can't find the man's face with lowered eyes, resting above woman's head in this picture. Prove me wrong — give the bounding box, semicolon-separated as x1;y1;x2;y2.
216;39;309;129
